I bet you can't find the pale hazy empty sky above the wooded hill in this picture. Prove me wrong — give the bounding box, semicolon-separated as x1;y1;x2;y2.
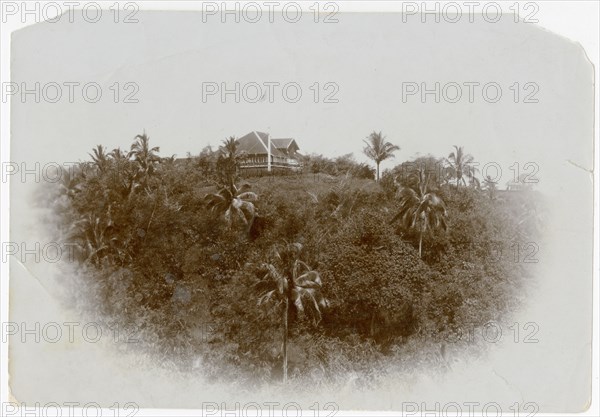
11;12;593;190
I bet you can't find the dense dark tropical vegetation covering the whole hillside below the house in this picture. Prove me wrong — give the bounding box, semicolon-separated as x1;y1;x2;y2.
52;133;541;386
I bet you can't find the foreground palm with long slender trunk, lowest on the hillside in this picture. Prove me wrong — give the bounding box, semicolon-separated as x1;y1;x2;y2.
258;242;329;384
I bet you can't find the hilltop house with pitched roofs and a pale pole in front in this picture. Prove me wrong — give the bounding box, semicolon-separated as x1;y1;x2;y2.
237;131;302;172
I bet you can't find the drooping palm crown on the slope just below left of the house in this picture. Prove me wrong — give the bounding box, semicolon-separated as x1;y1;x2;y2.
204;180;258;232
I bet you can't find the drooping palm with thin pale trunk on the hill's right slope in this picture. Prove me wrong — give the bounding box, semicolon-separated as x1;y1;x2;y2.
391;169;447;258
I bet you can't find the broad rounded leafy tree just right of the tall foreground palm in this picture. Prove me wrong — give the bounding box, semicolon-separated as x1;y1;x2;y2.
319;210;429;341
